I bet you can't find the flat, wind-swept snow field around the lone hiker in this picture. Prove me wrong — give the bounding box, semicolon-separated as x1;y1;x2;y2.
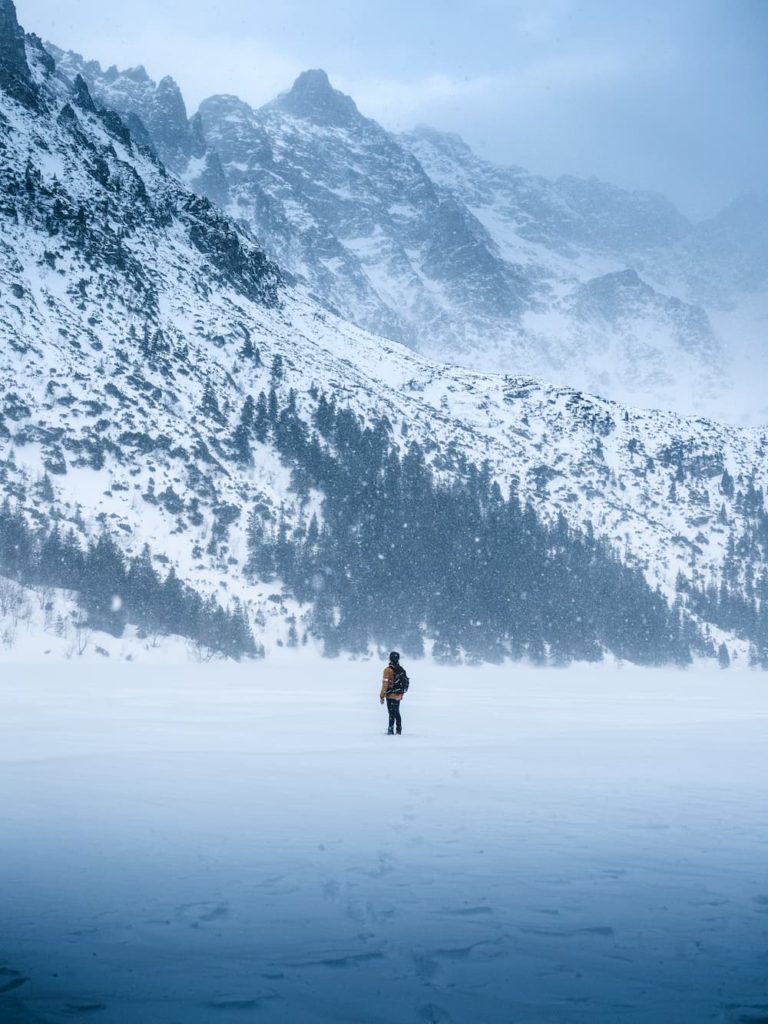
0;652;768;1024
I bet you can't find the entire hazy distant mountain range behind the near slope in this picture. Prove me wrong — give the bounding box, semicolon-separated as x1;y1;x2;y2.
46;48;768;422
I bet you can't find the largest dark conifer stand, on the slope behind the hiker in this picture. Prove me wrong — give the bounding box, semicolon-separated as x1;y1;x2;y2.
244;386;700;665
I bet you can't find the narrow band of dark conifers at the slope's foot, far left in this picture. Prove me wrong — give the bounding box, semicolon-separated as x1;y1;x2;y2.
0;501;262;658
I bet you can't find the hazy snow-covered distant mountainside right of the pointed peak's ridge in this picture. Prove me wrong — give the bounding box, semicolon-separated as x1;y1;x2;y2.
401;126;768;420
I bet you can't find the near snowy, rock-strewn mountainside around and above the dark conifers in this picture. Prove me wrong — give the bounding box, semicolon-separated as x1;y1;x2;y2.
0;0;768;663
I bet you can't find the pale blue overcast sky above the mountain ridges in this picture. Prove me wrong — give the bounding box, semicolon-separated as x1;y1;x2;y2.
17;0;768;217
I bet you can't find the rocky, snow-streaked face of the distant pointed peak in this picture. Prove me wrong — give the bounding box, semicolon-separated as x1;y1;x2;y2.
187;71;529;354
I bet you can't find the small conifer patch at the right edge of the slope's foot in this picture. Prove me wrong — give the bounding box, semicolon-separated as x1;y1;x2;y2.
677;472;768;669
